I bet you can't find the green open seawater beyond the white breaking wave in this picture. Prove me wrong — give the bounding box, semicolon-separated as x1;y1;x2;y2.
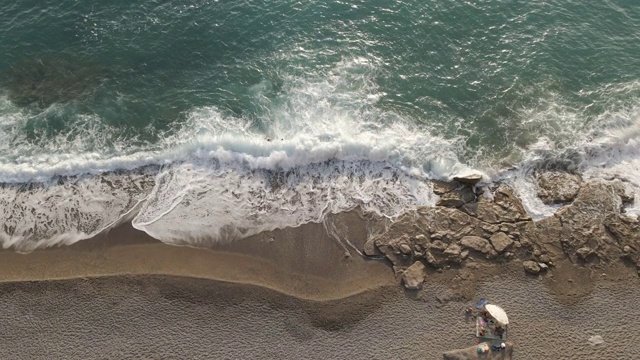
0;0;640;170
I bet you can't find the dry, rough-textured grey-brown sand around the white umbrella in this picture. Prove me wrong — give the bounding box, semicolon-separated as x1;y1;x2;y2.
0;276;640;360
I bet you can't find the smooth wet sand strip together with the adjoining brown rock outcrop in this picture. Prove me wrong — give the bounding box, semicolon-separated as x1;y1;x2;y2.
0;172;640;302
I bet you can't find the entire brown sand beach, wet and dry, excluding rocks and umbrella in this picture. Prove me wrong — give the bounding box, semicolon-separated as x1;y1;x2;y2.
0;214;640;360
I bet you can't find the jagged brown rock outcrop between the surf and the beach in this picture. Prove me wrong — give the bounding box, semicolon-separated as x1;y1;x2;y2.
364;172;640;289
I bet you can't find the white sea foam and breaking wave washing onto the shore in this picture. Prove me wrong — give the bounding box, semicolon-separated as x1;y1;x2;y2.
0;59;640;251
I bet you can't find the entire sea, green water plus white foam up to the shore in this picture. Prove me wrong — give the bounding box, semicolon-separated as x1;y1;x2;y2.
0;0;640;251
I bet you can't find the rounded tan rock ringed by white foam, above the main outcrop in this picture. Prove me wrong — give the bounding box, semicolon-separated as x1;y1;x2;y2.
538;171;582;204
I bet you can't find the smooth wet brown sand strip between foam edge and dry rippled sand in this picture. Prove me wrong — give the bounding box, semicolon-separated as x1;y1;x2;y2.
0;217;397;301
